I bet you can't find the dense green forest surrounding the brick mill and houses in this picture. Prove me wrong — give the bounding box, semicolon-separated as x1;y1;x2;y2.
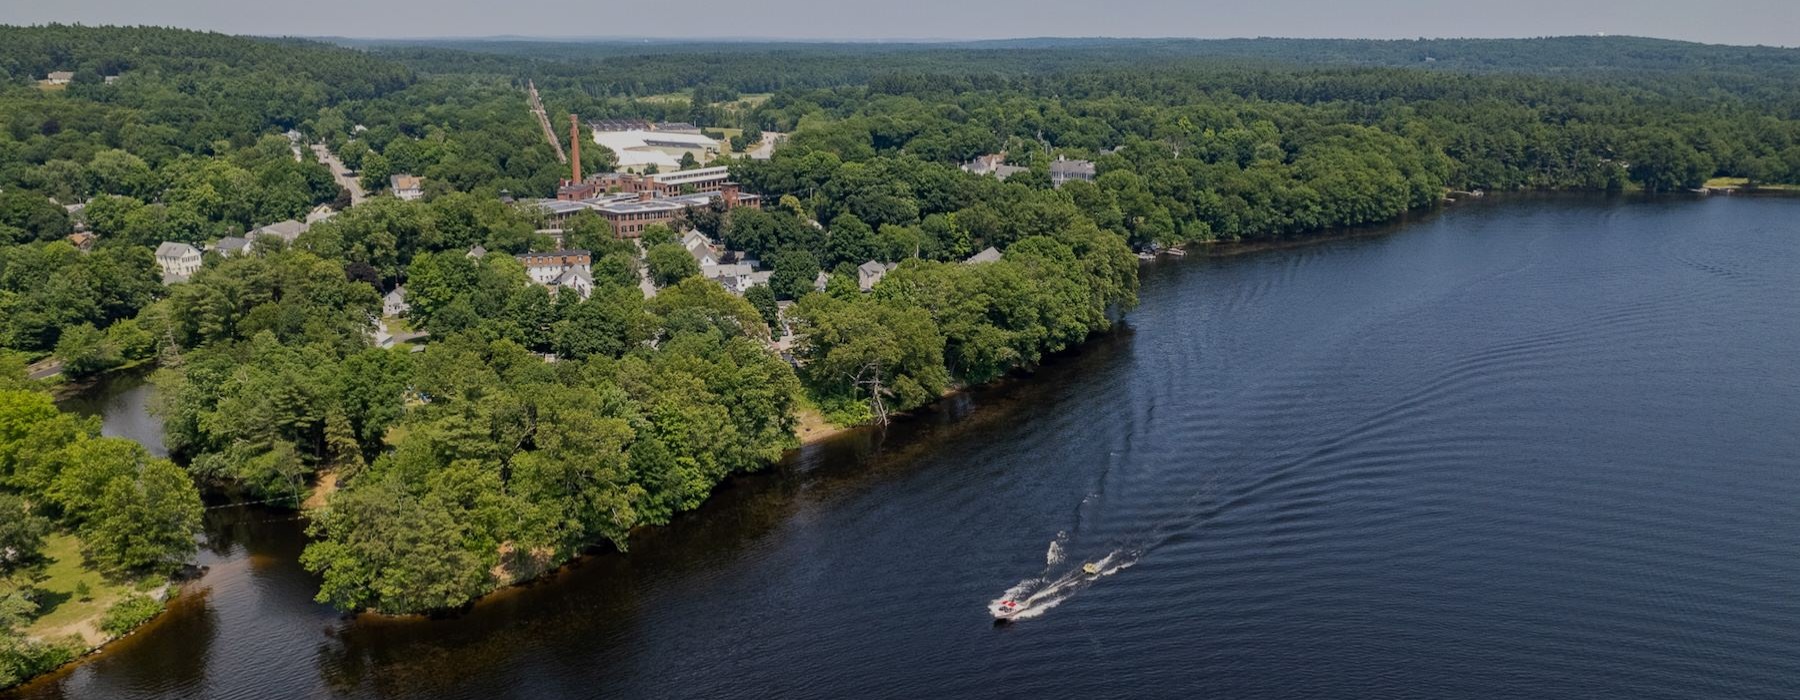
0;27;1800;640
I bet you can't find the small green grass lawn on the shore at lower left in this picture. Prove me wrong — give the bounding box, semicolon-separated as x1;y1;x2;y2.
25;533;158;644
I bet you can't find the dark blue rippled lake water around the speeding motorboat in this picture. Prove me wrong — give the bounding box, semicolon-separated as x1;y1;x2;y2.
10;198;1800;698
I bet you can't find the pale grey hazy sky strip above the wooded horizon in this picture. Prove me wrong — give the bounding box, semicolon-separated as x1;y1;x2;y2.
0;0;1800;47
